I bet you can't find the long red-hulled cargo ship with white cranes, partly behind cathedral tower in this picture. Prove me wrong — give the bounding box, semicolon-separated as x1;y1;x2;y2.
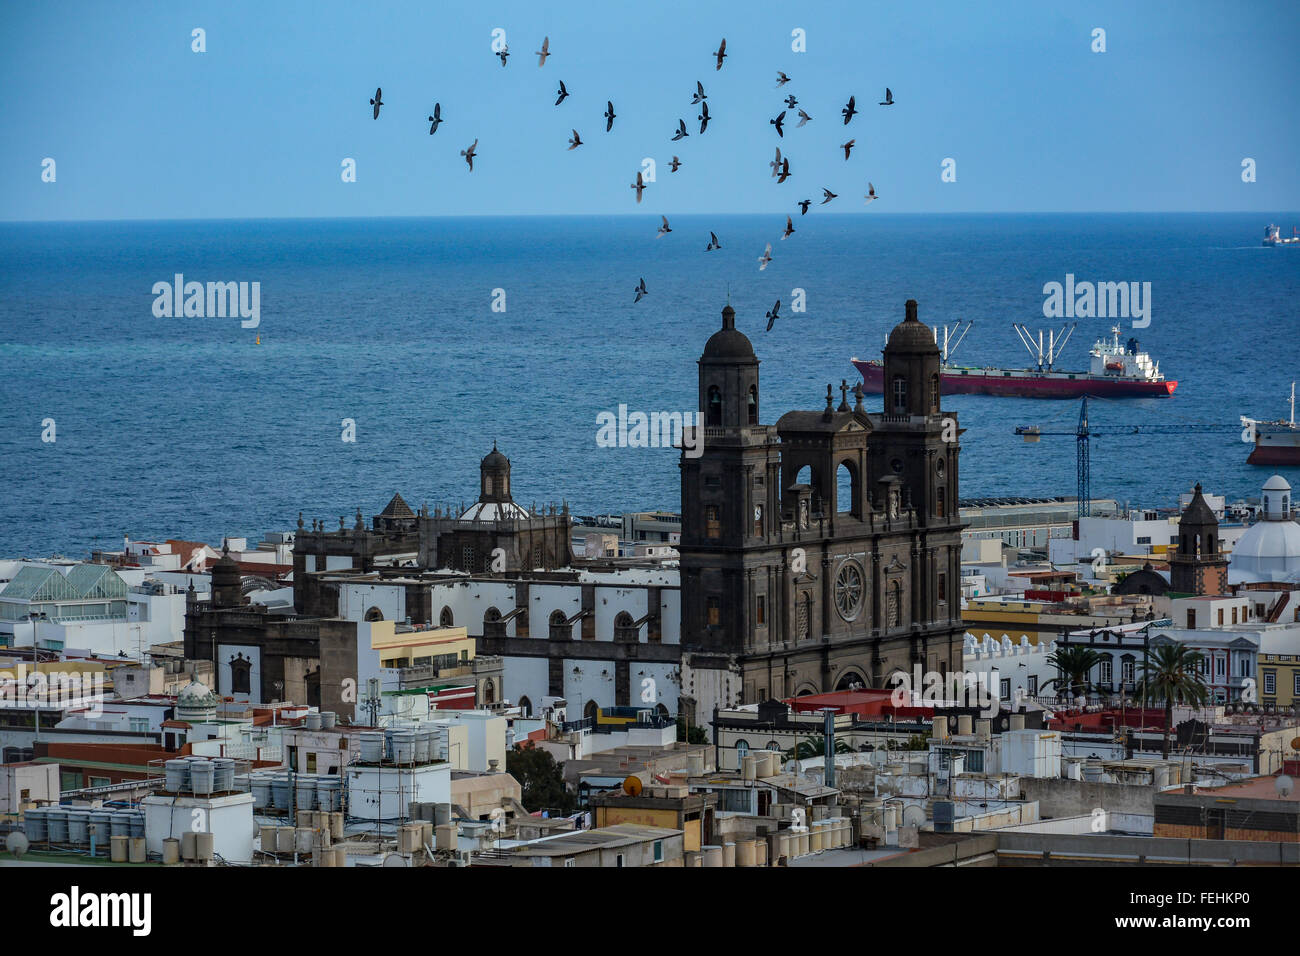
852;323;1178;398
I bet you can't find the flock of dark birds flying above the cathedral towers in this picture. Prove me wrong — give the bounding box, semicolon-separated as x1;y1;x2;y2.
371;36;894;325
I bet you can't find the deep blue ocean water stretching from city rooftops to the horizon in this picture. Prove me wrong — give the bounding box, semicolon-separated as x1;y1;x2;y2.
0;214;1300;557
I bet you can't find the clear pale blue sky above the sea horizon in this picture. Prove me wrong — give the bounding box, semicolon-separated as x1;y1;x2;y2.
0;0;1300;220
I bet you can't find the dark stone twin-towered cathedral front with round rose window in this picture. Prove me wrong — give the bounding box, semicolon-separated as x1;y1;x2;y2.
679;299;963;721
